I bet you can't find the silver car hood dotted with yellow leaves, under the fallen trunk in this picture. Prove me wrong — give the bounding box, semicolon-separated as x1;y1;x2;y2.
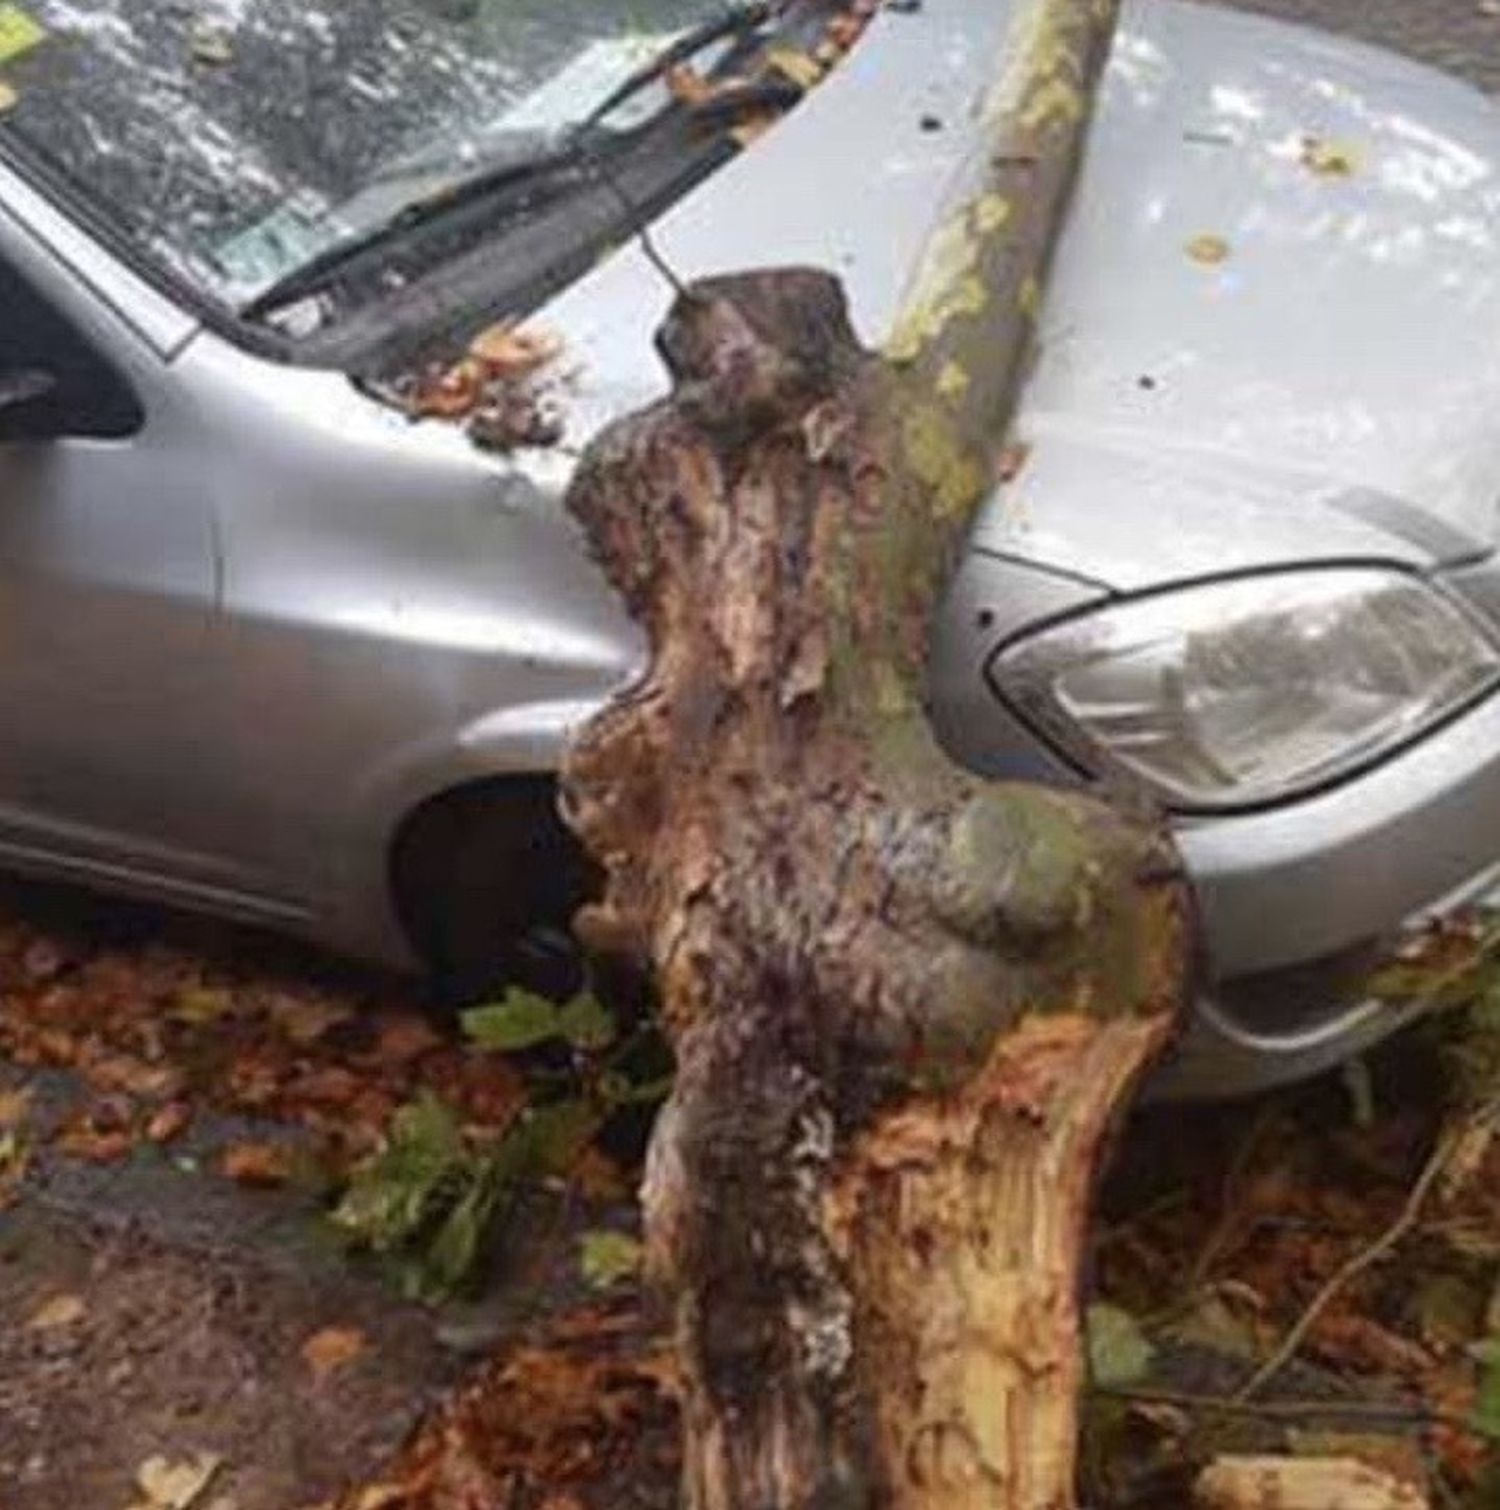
544;0;1500;590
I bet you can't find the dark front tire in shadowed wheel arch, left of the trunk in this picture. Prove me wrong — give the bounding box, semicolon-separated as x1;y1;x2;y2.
394;778;592;1007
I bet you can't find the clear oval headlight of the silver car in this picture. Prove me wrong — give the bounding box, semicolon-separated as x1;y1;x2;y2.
989;568;1500;811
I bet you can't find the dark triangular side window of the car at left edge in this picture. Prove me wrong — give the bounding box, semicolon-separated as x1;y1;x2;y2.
0;258;144;441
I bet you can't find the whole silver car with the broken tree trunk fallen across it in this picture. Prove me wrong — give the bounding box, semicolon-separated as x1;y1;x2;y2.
0;0;1500;1093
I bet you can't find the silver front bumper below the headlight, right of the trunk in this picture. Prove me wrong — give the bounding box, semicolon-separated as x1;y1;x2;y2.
1151;661;1500;1098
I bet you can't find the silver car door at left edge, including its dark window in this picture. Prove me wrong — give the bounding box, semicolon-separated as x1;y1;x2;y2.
0;221;253;897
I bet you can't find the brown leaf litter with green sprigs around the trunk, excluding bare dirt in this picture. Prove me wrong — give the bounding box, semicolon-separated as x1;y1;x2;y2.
0;881;1500;1510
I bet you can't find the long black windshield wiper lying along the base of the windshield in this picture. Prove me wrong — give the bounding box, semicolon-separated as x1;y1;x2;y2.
239;0;802;320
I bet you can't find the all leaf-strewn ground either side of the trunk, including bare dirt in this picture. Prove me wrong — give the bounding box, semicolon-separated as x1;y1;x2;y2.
0;869;1500;1510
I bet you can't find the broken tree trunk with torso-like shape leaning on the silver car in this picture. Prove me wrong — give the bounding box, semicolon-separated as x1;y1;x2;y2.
563;0;1187;1510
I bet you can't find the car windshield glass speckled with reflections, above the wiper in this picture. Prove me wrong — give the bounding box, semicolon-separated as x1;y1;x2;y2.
0;0;719;305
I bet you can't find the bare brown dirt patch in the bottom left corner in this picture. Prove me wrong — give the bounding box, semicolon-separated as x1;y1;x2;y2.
0;1203;458;1510
